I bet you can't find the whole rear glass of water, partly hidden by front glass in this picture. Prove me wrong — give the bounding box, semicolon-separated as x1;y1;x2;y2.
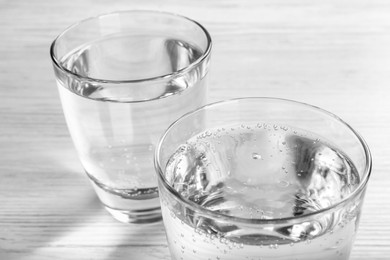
50;11;211;223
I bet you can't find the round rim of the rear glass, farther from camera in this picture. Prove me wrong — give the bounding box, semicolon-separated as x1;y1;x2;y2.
50;10;212;84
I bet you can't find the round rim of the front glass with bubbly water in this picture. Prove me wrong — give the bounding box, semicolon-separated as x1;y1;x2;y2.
154;97;372;225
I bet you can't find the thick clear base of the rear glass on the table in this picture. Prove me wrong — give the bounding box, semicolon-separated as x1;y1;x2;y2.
105;206;162;224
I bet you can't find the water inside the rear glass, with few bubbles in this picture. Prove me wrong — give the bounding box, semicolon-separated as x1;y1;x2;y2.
58;34;206;218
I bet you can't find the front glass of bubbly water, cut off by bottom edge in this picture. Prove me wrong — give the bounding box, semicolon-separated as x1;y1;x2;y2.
155;98;371;260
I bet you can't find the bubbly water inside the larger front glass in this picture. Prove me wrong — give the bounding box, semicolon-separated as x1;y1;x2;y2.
162;123;361;260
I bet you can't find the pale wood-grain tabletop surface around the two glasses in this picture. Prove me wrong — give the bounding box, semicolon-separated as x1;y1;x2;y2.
0;0;390;260
